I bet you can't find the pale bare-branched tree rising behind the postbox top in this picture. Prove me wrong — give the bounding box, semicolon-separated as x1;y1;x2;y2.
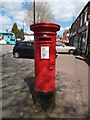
25;0;53;25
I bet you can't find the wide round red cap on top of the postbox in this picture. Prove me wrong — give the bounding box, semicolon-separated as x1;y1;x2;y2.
30;23;60;32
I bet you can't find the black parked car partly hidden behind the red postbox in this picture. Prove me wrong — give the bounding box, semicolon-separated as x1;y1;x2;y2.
13;41;34;58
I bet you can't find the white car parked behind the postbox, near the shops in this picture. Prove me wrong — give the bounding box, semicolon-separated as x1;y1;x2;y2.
56;41;76;54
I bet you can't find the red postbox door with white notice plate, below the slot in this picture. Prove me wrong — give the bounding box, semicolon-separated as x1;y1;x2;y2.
36;44;55;92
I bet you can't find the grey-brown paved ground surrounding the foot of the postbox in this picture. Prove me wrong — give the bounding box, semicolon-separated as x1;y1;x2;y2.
0;53;89;118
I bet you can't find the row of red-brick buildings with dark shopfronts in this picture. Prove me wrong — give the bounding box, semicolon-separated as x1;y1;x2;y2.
69;1;90;55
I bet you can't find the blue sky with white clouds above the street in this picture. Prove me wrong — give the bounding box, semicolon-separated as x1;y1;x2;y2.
0;0;89;34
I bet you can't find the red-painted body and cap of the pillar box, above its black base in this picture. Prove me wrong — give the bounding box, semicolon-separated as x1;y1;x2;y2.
30;23;60;93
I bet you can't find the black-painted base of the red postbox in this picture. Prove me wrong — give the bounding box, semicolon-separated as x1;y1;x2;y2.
33;90;55;111
